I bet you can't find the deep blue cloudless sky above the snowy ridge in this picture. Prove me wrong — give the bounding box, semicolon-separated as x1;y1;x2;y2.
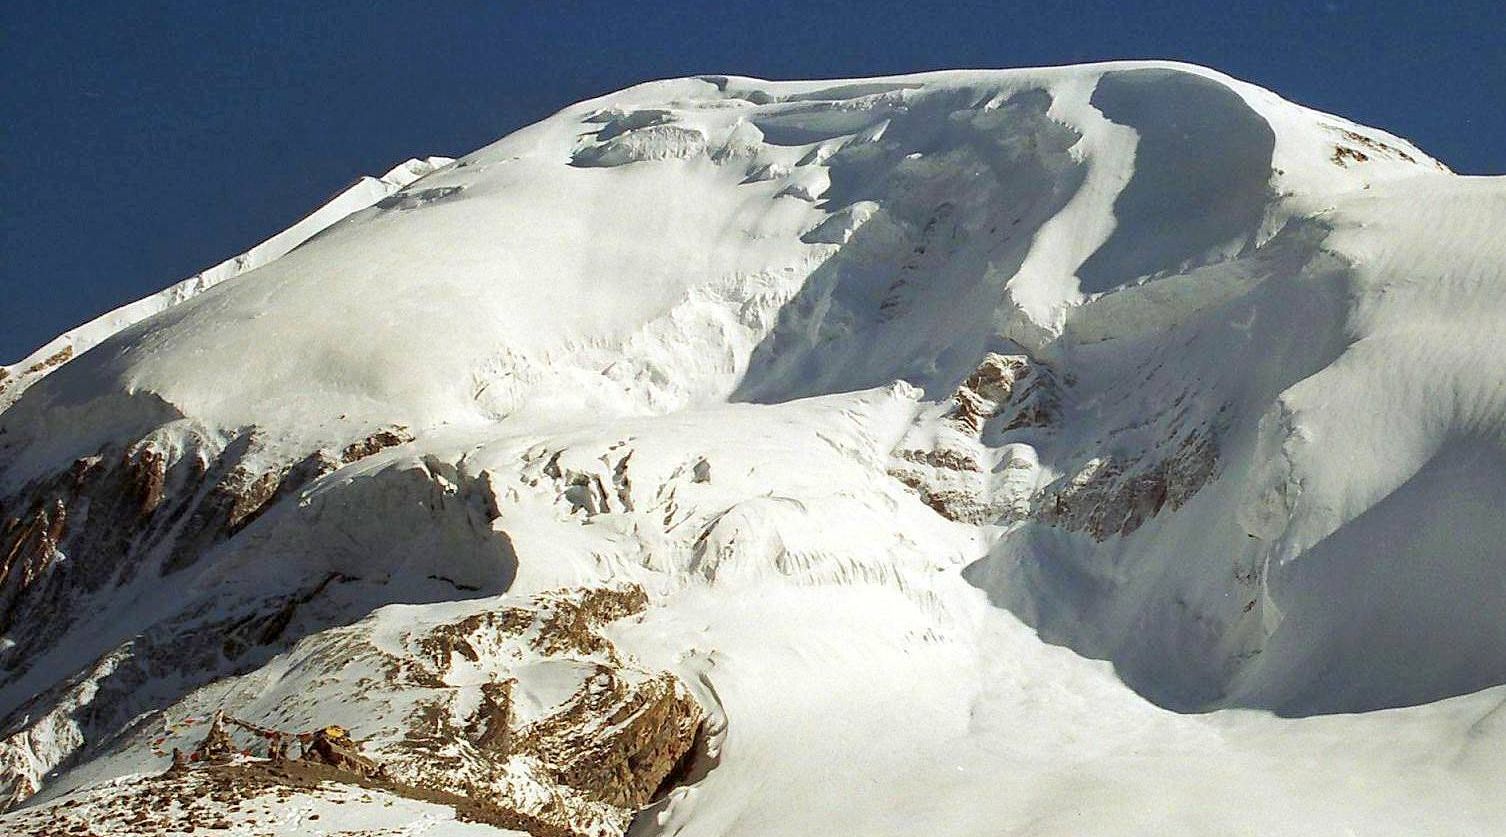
0;0;1506;363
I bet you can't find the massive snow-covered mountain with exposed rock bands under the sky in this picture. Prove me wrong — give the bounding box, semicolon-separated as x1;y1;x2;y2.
0;62;1506;835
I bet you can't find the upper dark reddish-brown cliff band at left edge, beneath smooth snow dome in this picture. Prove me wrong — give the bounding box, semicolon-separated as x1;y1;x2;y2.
0;426;424;671
